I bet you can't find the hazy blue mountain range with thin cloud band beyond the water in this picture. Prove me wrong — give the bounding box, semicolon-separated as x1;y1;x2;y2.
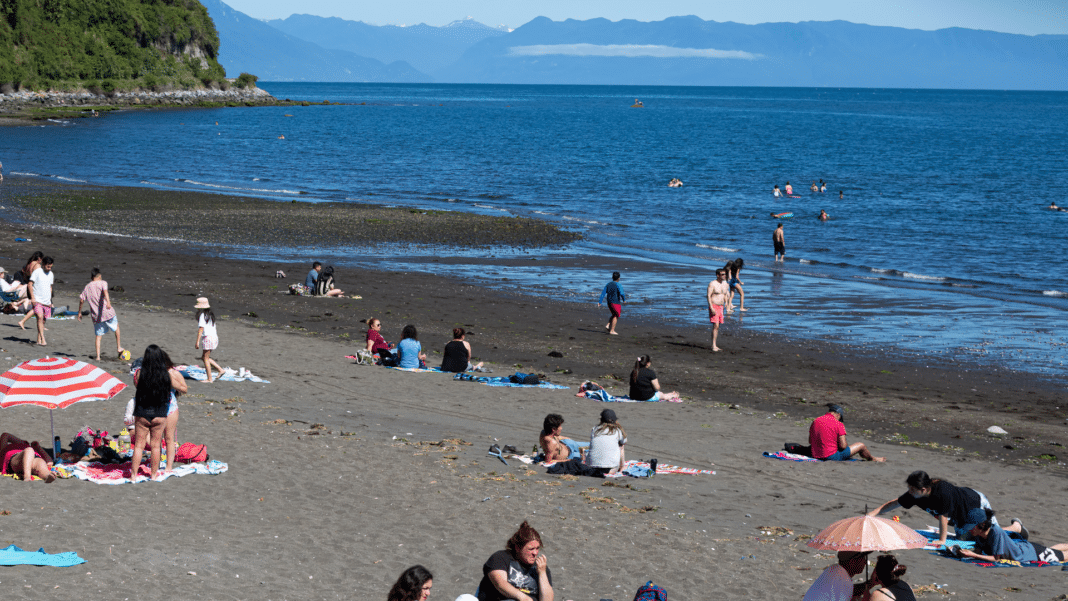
202;0;1068;90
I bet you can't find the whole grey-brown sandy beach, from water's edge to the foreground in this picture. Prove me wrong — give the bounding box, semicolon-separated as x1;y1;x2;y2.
0;185;1068;601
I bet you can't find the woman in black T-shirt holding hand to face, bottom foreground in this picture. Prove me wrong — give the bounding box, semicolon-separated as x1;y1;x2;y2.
478;520;553;601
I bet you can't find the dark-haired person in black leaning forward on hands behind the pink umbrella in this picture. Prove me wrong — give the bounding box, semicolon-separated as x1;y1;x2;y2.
868;470;1026;545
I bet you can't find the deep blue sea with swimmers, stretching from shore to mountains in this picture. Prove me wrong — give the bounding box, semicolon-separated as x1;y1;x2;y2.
0;83;1068;375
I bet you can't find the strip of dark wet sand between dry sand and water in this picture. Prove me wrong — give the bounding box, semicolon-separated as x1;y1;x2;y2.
0;181;1068;473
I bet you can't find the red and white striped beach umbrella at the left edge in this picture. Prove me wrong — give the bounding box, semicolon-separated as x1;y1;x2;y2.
0;357;126;409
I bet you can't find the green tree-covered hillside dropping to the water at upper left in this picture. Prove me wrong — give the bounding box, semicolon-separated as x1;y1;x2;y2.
0;0;232;92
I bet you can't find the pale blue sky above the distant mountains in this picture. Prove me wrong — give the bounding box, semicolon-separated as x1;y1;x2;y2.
223;0;1068;34
